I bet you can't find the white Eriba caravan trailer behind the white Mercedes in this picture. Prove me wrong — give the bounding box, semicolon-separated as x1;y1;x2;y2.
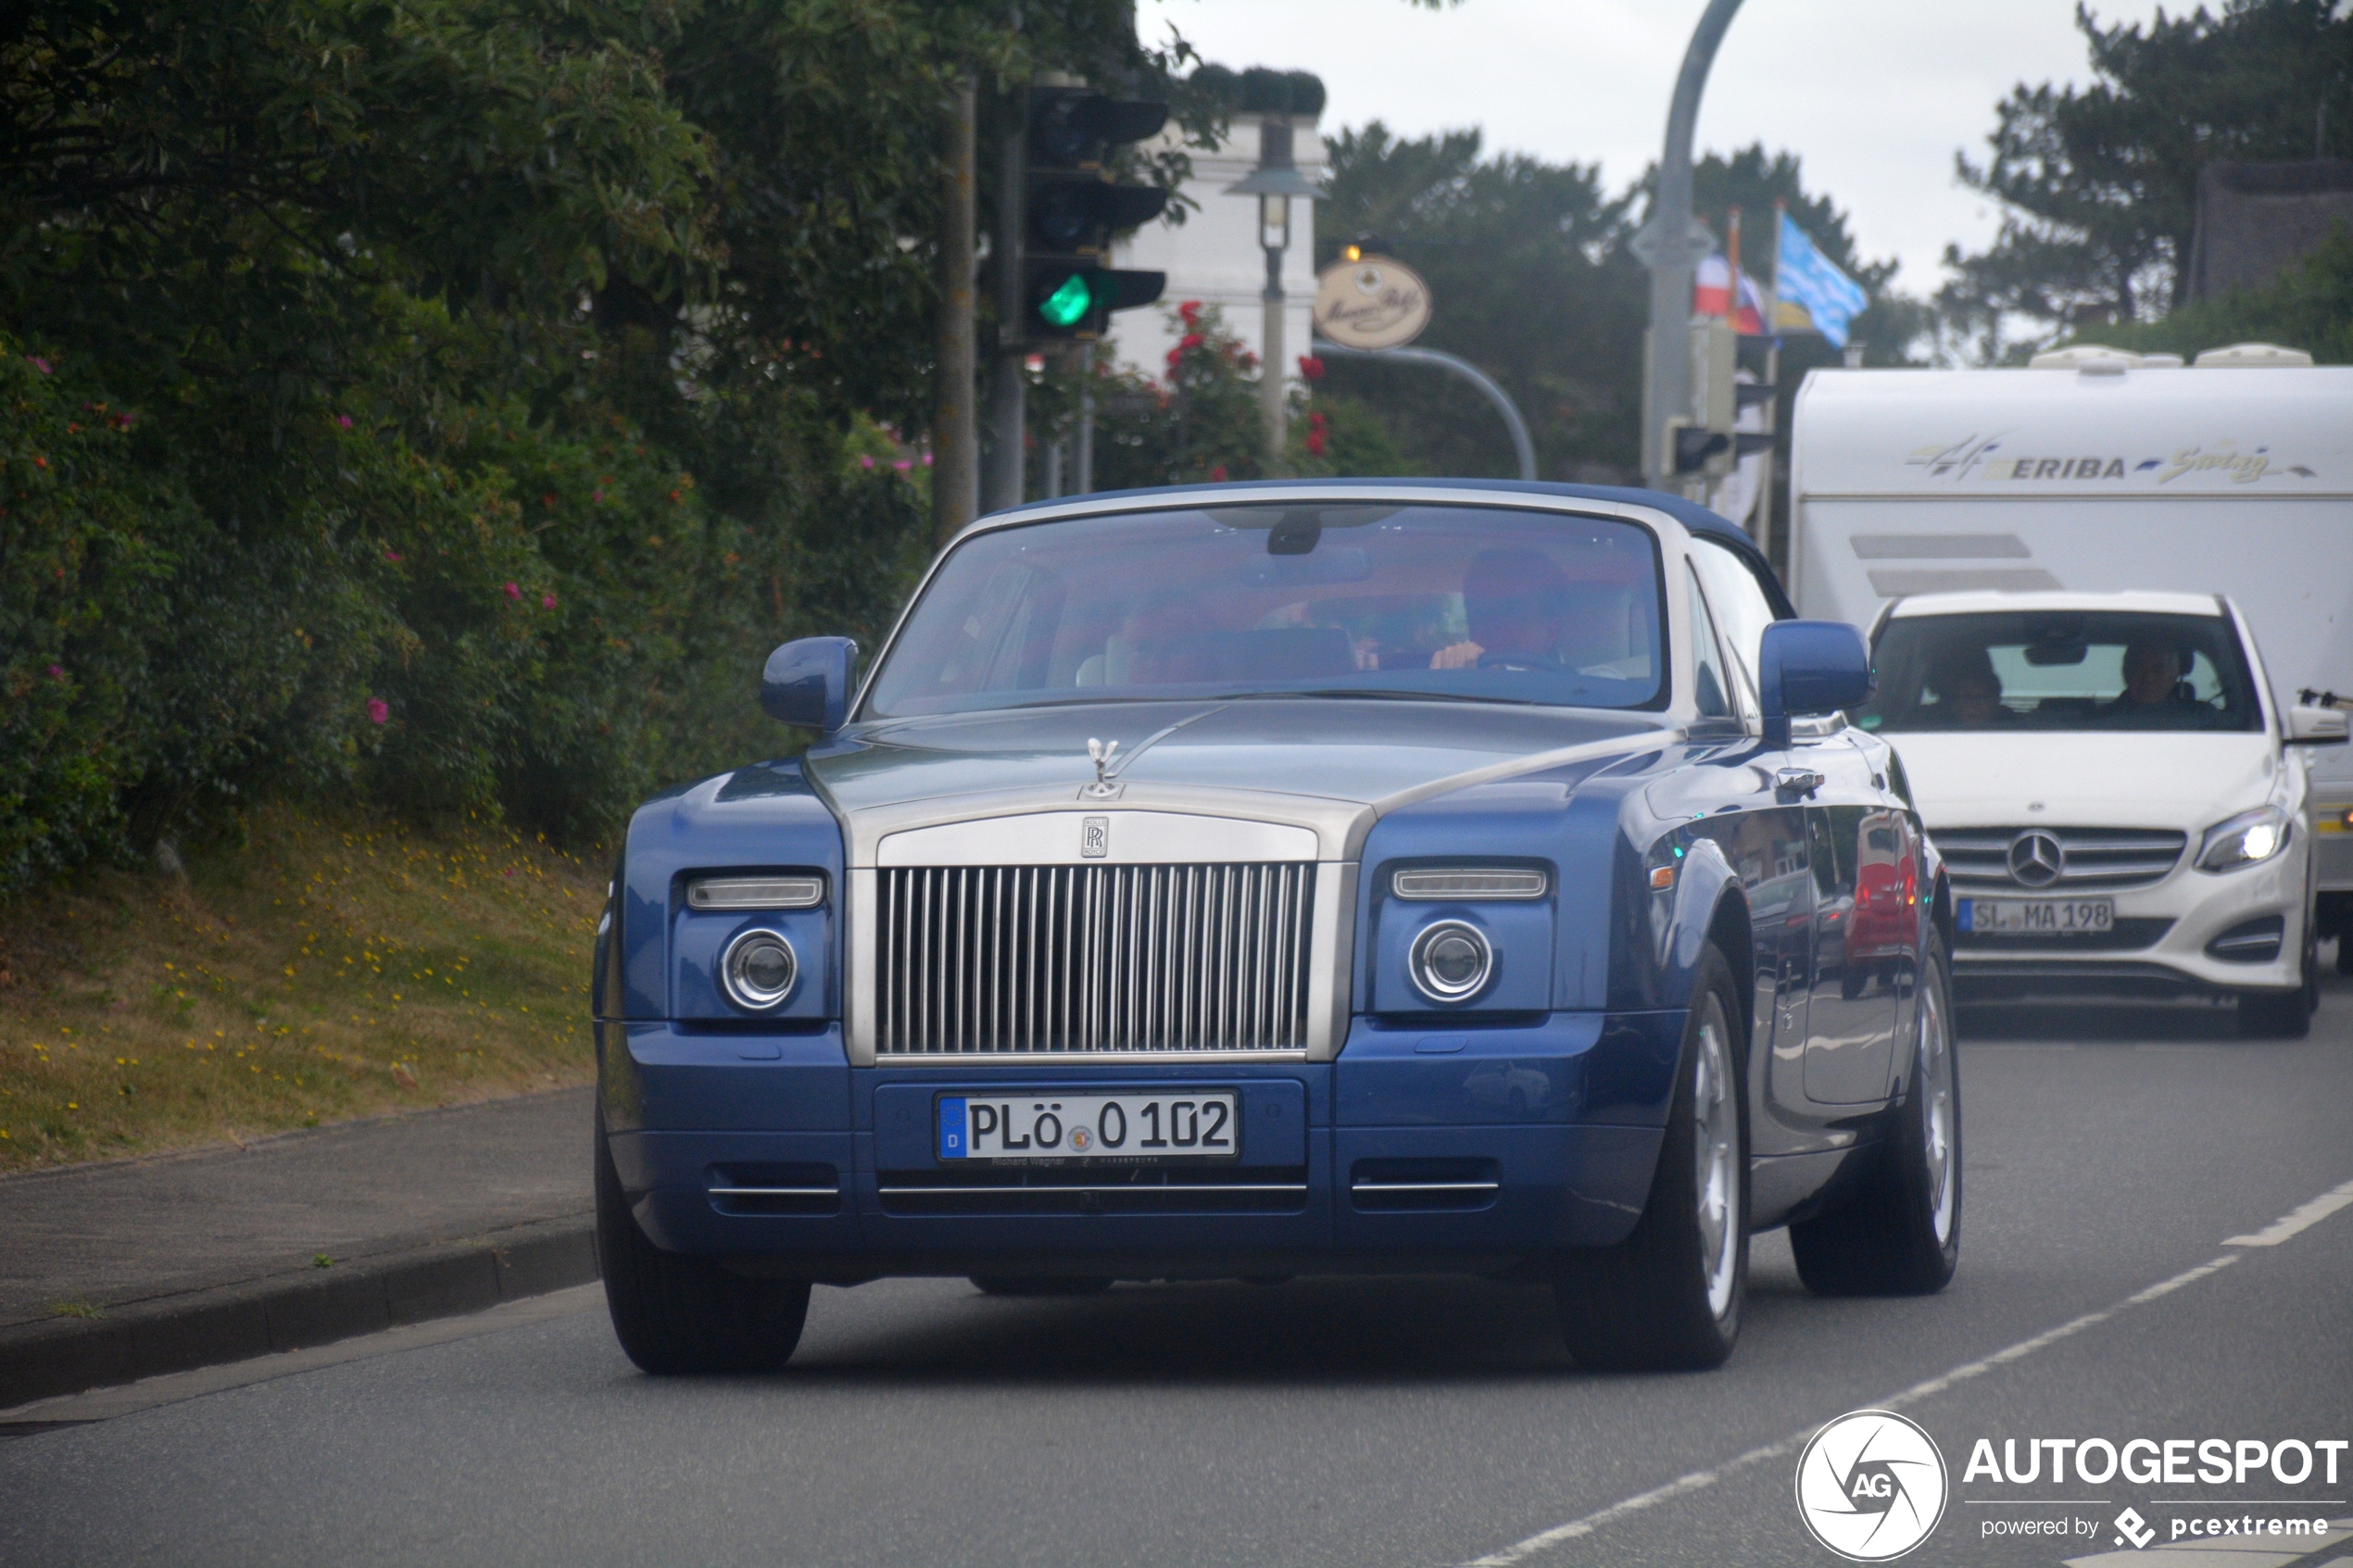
1788;344;2353;973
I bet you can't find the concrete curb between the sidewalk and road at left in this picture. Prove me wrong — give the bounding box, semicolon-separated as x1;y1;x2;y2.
0;1215;598;1408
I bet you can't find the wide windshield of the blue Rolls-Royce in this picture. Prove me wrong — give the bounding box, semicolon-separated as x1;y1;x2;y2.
866;503;1666;717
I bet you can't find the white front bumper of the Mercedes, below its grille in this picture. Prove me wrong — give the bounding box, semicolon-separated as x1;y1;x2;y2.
1953;827;2310;997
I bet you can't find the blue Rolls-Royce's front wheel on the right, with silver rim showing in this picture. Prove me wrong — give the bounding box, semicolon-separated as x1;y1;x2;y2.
1553;943;1748;1371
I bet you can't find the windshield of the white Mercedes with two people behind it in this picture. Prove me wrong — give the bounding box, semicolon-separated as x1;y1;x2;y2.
1856;608;2263;731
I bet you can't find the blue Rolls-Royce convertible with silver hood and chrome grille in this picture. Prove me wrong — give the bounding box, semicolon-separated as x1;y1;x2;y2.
596;482;1960;1373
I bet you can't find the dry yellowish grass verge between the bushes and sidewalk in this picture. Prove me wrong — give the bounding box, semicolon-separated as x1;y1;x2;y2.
0;807;605;1171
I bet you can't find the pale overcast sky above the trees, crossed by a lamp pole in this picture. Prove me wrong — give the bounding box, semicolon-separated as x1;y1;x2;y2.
1139;0;2191;294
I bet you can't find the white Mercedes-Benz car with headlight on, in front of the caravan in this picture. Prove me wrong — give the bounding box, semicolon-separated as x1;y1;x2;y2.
1856;593;2346;1036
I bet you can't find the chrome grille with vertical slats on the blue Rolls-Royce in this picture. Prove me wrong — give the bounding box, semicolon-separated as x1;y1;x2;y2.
873;863;1315;1058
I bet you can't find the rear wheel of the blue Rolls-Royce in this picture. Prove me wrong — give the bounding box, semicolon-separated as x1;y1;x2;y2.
1788;931;1962;1296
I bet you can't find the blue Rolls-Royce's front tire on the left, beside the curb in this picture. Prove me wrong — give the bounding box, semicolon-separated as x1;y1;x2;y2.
596;1126;810;1377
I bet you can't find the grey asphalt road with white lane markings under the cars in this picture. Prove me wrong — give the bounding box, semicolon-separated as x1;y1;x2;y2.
0;978;2353;1568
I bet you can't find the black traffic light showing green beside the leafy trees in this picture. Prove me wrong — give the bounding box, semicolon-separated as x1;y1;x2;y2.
1007;87;1169;341
